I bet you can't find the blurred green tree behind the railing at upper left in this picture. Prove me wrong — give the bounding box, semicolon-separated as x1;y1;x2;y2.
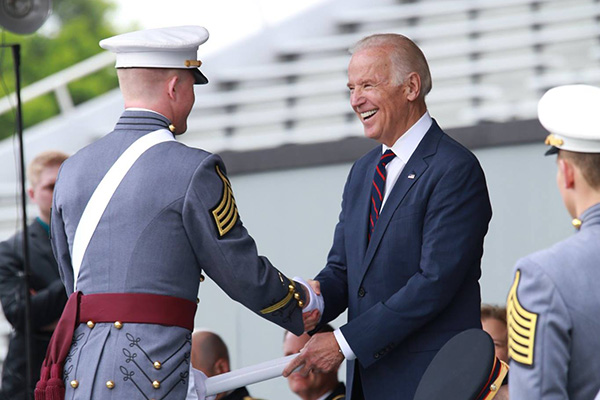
0;0;118;139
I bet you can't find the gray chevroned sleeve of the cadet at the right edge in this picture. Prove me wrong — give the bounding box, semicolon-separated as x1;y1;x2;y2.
507;258;573;399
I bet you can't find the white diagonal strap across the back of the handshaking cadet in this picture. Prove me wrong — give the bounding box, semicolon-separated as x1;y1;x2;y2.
71;129;175;290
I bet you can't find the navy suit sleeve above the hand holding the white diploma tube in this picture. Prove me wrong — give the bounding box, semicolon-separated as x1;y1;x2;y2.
332;158;491;367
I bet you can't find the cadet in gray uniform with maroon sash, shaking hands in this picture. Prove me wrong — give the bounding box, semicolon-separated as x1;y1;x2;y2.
36;26;316;400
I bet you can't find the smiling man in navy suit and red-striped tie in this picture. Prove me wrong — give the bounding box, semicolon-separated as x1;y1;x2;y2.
284;34;492;400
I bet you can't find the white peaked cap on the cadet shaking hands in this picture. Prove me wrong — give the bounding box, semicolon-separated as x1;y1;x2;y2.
100;26;208;84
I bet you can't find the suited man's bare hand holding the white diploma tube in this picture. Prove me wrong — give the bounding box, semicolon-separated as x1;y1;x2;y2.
283;332;344;377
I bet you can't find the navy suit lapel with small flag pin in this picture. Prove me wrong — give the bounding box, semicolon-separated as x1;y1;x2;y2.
361;120;443;281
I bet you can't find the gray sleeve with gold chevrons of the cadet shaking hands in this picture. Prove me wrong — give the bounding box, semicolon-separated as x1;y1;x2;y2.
183;155;306;335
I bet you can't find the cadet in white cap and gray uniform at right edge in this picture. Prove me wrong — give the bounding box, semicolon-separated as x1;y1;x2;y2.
507;85;600;400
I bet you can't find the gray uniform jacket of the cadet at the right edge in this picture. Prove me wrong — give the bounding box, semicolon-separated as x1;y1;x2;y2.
507;204;600;400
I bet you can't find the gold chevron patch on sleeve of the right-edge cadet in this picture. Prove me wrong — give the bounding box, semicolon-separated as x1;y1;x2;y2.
506;270;538;366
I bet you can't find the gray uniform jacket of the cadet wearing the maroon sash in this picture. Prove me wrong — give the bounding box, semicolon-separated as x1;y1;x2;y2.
51;111;303;400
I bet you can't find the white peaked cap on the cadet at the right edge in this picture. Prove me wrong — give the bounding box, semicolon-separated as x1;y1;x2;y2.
538;85;600;155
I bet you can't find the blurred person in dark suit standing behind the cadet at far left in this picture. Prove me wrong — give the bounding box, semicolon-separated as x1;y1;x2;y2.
0;151;68;400
